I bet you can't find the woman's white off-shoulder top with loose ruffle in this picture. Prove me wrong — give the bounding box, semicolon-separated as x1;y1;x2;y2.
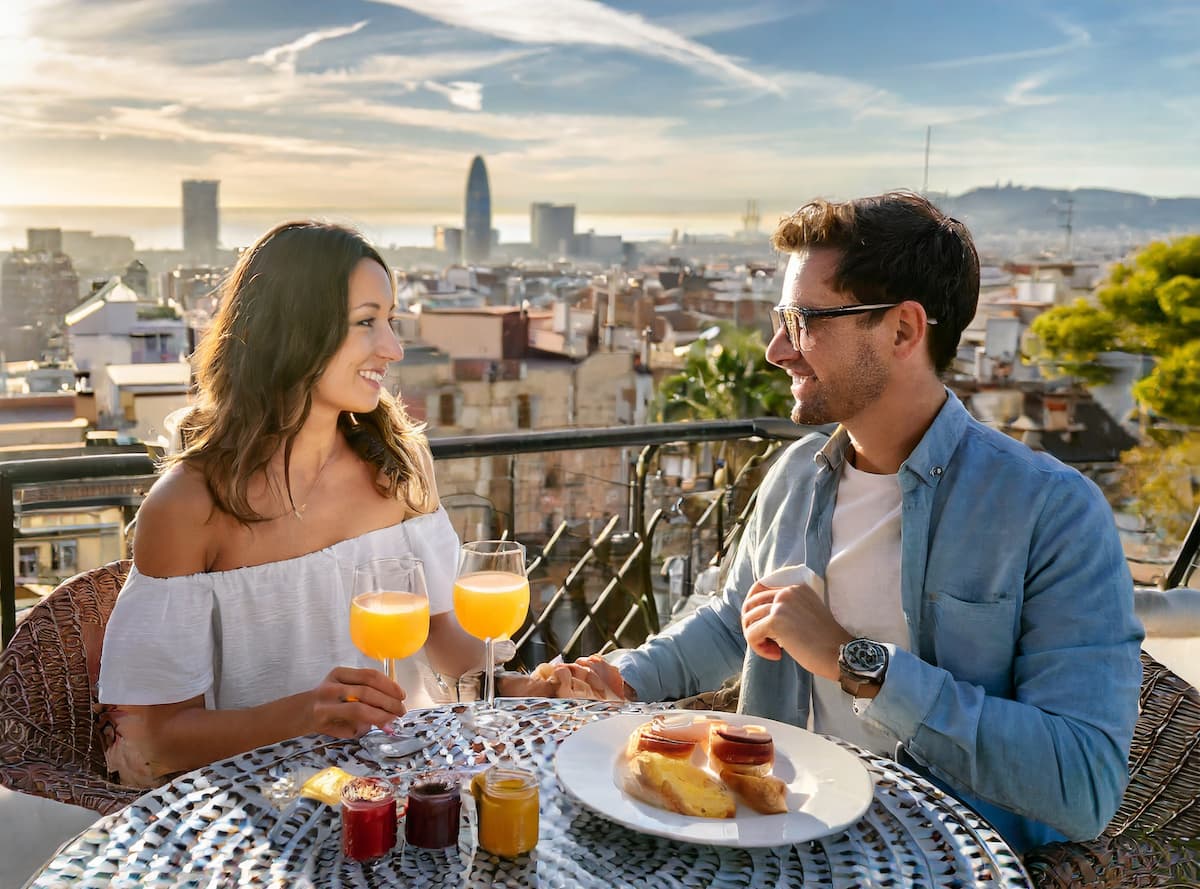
98;507;460;709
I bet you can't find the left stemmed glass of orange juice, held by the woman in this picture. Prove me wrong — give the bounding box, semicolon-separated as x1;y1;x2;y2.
350;555;430;758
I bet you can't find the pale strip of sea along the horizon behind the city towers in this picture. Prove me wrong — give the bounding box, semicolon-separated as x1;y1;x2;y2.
0;204;742;251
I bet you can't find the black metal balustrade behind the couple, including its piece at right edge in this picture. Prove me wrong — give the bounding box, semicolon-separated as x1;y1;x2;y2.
0;427;1200;666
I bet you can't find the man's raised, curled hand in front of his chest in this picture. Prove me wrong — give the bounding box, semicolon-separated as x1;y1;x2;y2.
742;575;854;681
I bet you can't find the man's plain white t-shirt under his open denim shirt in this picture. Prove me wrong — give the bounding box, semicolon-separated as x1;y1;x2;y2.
812;461;908;756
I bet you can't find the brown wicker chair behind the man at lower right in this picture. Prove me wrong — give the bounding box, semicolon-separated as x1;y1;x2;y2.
1025;651;1200;889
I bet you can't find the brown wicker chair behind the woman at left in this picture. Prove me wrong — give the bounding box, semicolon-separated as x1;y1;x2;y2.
0;561;144;815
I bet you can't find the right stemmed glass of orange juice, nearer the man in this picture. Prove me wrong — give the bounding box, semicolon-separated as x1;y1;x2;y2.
454;540;529;728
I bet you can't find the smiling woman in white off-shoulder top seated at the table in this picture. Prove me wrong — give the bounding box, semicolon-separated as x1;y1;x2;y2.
100;222;479;785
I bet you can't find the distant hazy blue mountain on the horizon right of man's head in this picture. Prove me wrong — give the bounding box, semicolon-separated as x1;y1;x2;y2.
935;185;1200;234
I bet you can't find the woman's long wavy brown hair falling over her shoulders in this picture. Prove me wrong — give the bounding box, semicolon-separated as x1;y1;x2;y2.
167;222;434;523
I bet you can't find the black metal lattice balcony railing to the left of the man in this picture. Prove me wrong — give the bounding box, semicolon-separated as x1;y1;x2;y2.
0;419;806;647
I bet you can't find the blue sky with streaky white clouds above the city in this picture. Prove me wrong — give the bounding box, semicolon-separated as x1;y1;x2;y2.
0;0;1200;216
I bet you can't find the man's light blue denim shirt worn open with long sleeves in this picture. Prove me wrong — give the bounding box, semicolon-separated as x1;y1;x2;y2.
613;392;1142;852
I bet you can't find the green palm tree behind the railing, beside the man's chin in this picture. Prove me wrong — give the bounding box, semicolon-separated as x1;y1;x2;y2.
654;325;792;422
